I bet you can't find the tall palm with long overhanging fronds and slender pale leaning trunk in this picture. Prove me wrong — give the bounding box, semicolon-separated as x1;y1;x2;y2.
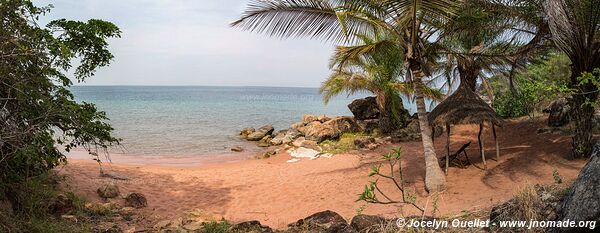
232;0;460;192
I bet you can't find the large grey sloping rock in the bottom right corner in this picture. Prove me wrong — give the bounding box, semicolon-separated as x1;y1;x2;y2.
557;141;600;232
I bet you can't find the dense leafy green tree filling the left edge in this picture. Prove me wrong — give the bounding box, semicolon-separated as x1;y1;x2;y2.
0;0;120;204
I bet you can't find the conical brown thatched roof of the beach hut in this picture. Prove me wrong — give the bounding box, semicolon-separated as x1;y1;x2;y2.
428;85;503;126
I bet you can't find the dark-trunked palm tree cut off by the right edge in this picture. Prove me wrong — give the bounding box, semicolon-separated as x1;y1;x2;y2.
544;0;600;158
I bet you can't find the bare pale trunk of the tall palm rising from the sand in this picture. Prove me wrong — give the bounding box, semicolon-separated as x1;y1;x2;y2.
411;70;446;193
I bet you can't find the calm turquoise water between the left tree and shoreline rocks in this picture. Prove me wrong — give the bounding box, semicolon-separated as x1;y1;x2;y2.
71;86;376;155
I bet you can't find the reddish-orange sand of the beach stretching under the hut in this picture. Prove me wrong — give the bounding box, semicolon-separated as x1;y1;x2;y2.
62;121;585;228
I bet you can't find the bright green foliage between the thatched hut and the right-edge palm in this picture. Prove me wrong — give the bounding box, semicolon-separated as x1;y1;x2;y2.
492;53;570;118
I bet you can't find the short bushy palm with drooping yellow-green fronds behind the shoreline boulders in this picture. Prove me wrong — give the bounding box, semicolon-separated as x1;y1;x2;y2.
320;34;442;133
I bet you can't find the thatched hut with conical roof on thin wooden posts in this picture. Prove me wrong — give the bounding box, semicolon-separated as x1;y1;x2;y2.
427;83;504;174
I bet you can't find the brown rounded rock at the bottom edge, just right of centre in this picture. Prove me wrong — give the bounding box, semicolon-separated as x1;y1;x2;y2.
288;210;356;232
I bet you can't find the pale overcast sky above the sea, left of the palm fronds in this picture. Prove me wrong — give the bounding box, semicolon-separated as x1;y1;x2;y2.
34;0;333;87
